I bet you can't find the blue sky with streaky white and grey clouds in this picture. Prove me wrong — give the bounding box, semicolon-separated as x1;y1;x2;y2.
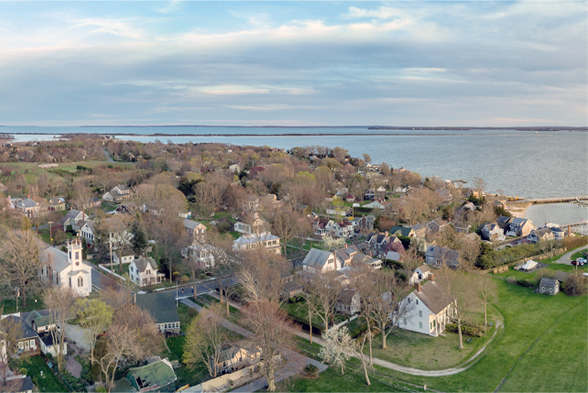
0;1;588;127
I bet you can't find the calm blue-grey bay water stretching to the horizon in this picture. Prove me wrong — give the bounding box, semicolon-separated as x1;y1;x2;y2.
0;127;588;199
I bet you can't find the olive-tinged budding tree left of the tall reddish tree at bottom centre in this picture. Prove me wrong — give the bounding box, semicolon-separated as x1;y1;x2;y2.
182;304;228;378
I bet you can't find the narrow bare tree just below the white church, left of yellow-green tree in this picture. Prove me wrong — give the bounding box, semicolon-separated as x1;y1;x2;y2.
43;287;76;372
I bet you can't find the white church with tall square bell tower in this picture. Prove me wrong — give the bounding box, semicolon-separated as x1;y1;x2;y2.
40;238;92;296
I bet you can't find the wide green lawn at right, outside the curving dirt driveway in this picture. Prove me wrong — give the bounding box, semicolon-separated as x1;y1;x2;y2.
358;280;588;392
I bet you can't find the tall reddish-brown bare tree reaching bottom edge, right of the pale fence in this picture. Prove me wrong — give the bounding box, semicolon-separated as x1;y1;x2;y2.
243;300;294;392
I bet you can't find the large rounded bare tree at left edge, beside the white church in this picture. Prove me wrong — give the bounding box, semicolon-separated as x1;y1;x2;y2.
0;230;43;307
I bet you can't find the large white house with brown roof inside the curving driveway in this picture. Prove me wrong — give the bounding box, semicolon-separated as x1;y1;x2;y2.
398;274;454;337
